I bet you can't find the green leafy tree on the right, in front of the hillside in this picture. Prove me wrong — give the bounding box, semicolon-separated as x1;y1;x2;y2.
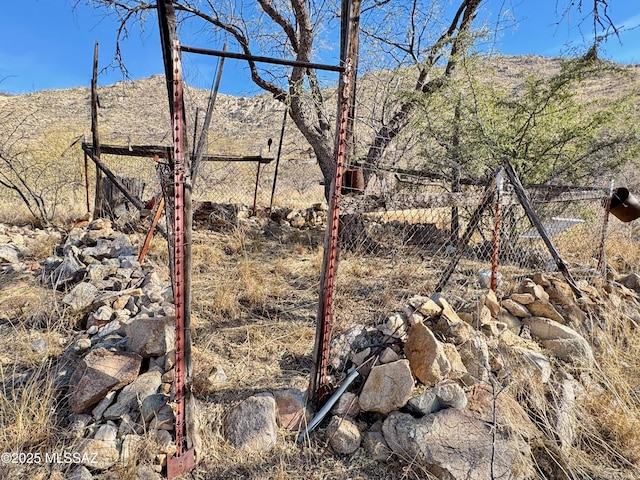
414;57;640;185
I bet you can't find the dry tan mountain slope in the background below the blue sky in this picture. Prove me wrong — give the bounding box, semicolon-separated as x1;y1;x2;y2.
0;55;640;162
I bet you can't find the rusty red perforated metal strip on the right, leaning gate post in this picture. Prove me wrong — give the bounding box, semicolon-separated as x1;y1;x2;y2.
309;60;352;402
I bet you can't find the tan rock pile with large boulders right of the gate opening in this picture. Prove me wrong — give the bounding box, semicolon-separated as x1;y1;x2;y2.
226;274;640;480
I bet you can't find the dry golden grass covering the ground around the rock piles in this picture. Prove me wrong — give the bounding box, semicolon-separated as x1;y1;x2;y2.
0;190;640;480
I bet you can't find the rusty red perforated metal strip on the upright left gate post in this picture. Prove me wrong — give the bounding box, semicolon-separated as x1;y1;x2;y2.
167;42;195;478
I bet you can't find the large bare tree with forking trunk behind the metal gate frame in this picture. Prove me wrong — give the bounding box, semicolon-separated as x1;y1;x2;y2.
75;0;611;197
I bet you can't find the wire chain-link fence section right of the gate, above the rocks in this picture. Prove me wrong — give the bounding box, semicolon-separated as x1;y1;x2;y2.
334;166;608;376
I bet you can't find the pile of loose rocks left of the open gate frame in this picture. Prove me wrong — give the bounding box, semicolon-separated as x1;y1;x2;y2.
42;219;175;478
